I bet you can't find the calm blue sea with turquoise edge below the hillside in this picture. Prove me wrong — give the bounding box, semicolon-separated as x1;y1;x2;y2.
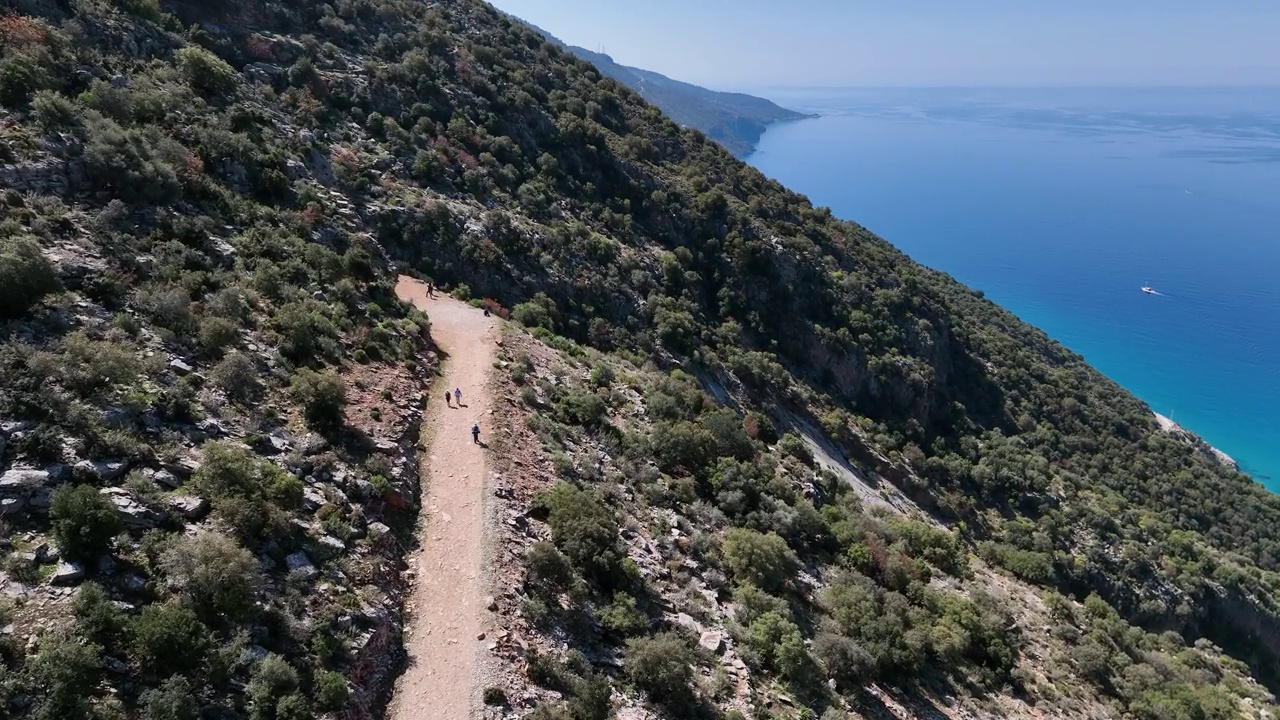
748;88;1280;492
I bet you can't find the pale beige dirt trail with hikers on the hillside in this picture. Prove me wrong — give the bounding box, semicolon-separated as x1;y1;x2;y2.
388;277;497;720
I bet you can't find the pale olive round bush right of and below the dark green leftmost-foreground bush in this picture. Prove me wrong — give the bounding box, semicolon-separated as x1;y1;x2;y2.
160;532;262;619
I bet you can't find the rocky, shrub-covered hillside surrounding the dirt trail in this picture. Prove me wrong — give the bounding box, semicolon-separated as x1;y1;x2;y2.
0;0;1280;720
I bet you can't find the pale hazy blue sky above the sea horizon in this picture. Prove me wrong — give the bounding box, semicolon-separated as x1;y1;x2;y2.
494;0;1280;90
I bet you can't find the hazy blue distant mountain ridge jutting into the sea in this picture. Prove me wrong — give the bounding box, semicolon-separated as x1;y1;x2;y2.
531;26;813;158
